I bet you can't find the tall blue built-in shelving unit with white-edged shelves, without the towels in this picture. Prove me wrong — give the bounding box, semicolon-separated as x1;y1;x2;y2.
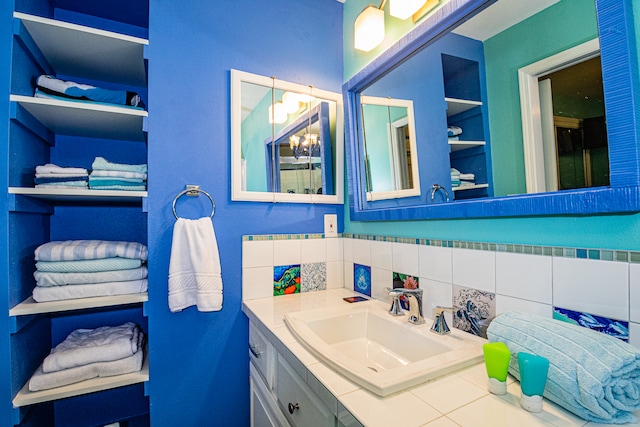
0;4;149;427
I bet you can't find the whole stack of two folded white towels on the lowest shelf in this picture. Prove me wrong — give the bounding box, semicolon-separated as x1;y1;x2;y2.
29;322;145;391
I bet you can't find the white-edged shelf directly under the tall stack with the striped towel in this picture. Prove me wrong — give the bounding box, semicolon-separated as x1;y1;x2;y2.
9;292;149;316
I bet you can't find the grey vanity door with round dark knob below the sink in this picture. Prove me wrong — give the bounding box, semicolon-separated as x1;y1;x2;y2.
276;355;335;427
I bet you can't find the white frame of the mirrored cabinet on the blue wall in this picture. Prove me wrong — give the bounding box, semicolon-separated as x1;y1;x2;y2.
230;69;344;204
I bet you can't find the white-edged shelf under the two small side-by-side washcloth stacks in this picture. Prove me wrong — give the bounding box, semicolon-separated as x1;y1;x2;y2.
9;187;147;202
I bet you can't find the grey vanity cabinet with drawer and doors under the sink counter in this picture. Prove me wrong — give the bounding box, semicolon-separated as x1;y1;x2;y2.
249;321;361;427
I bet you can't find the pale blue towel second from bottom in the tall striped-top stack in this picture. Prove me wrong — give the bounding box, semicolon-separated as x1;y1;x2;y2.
33;265;149;287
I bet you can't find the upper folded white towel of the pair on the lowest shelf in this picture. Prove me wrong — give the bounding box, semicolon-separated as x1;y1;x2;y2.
42;322;141;373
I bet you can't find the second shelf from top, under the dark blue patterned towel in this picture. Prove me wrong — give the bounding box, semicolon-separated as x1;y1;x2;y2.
10;95;148;141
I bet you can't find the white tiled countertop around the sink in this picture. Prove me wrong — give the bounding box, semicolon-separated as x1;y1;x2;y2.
243;289;640;427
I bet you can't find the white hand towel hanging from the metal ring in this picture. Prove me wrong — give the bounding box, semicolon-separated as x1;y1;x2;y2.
169;217;222;313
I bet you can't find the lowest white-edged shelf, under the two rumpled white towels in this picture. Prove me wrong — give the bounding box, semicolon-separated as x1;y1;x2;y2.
13;351;149;408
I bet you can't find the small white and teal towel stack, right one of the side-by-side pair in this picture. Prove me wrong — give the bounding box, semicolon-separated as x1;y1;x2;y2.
89;157;147;191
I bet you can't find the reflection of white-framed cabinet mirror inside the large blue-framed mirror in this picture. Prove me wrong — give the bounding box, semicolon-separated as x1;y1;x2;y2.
360;95;420;200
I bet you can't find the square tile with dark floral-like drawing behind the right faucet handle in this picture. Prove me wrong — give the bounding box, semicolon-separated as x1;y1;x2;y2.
453;286;496;338
